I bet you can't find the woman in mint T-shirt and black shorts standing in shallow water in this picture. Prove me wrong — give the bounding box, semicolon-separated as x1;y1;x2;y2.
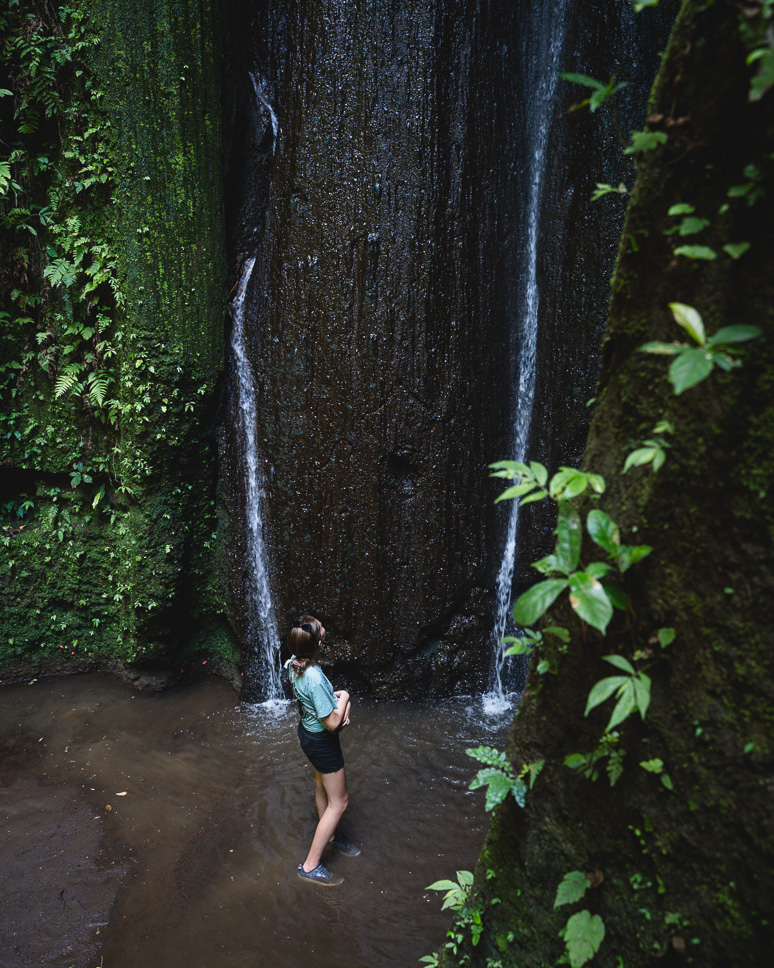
285;615;360;885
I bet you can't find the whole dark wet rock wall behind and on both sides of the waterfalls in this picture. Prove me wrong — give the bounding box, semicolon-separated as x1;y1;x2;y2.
222;0;667;695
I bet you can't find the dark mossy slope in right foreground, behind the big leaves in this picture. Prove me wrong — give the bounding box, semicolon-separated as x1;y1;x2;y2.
443;0;774;968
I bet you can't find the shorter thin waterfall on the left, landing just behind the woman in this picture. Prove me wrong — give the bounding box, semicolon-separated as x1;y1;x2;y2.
231;256;283;699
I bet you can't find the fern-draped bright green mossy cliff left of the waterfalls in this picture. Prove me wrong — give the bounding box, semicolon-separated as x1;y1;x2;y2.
0;0;235;676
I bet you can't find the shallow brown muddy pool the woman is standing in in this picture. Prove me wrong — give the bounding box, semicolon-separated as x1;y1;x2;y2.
0;675;512;968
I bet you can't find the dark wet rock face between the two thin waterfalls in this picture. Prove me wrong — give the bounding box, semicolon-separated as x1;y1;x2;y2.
225;0;516;695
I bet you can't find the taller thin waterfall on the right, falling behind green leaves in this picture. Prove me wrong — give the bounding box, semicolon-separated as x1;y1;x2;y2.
486;0;568;712
